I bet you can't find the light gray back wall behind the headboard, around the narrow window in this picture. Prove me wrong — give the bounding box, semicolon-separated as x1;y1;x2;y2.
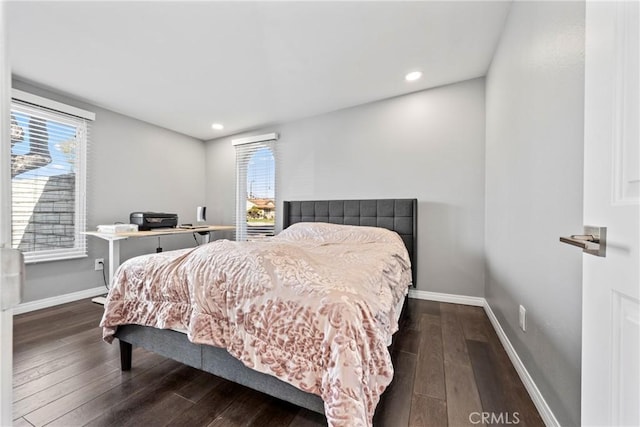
206;79;485;296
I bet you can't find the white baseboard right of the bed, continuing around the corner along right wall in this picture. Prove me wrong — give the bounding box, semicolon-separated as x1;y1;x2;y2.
409;289;560;427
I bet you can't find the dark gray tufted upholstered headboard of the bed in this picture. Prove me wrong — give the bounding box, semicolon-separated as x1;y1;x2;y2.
282;199;418;286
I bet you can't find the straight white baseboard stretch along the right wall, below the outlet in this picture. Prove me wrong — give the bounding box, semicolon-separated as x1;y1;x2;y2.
484;300;560;427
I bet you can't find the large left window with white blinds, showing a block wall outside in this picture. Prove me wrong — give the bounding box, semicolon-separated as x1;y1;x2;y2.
11;90;95;263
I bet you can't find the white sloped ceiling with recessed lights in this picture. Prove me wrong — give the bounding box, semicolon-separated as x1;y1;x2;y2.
6;1;510;140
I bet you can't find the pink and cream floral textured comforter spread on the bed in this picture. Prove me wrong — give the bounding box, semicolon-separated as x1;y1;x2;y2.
101;223;411;426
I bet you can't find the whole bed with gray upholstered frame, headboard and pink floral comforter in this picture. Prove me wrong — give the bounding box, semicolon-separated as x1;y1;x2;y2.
101;199;417;426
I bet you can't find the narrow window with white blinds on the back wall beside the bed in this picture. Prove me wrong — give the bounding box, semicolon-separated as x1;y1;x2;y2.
232;133;278;240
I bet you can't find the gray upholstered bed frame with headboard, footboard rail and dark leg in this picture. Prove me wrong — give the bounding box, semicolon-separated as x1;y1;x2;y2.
115;199;418;414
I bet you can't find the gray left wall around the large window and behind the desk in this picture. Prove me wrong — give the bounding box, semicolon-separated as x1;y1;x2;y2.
13;79;205;302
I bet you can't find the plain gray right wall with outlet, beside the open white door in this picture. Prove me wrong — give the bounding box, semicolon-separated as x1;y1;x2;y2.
486;1;584;425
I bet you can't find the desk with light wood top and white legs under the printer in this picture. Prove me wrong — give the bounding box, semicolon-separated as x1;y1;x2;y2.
84;225;235;286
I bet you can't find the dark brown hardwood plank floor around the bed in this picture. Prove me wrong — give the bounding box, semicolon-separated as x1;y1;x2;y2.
13;299;543;427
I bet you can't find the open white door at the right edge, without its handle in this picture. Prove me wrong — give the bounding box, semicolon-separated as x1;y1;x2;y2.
582;1;640;426
